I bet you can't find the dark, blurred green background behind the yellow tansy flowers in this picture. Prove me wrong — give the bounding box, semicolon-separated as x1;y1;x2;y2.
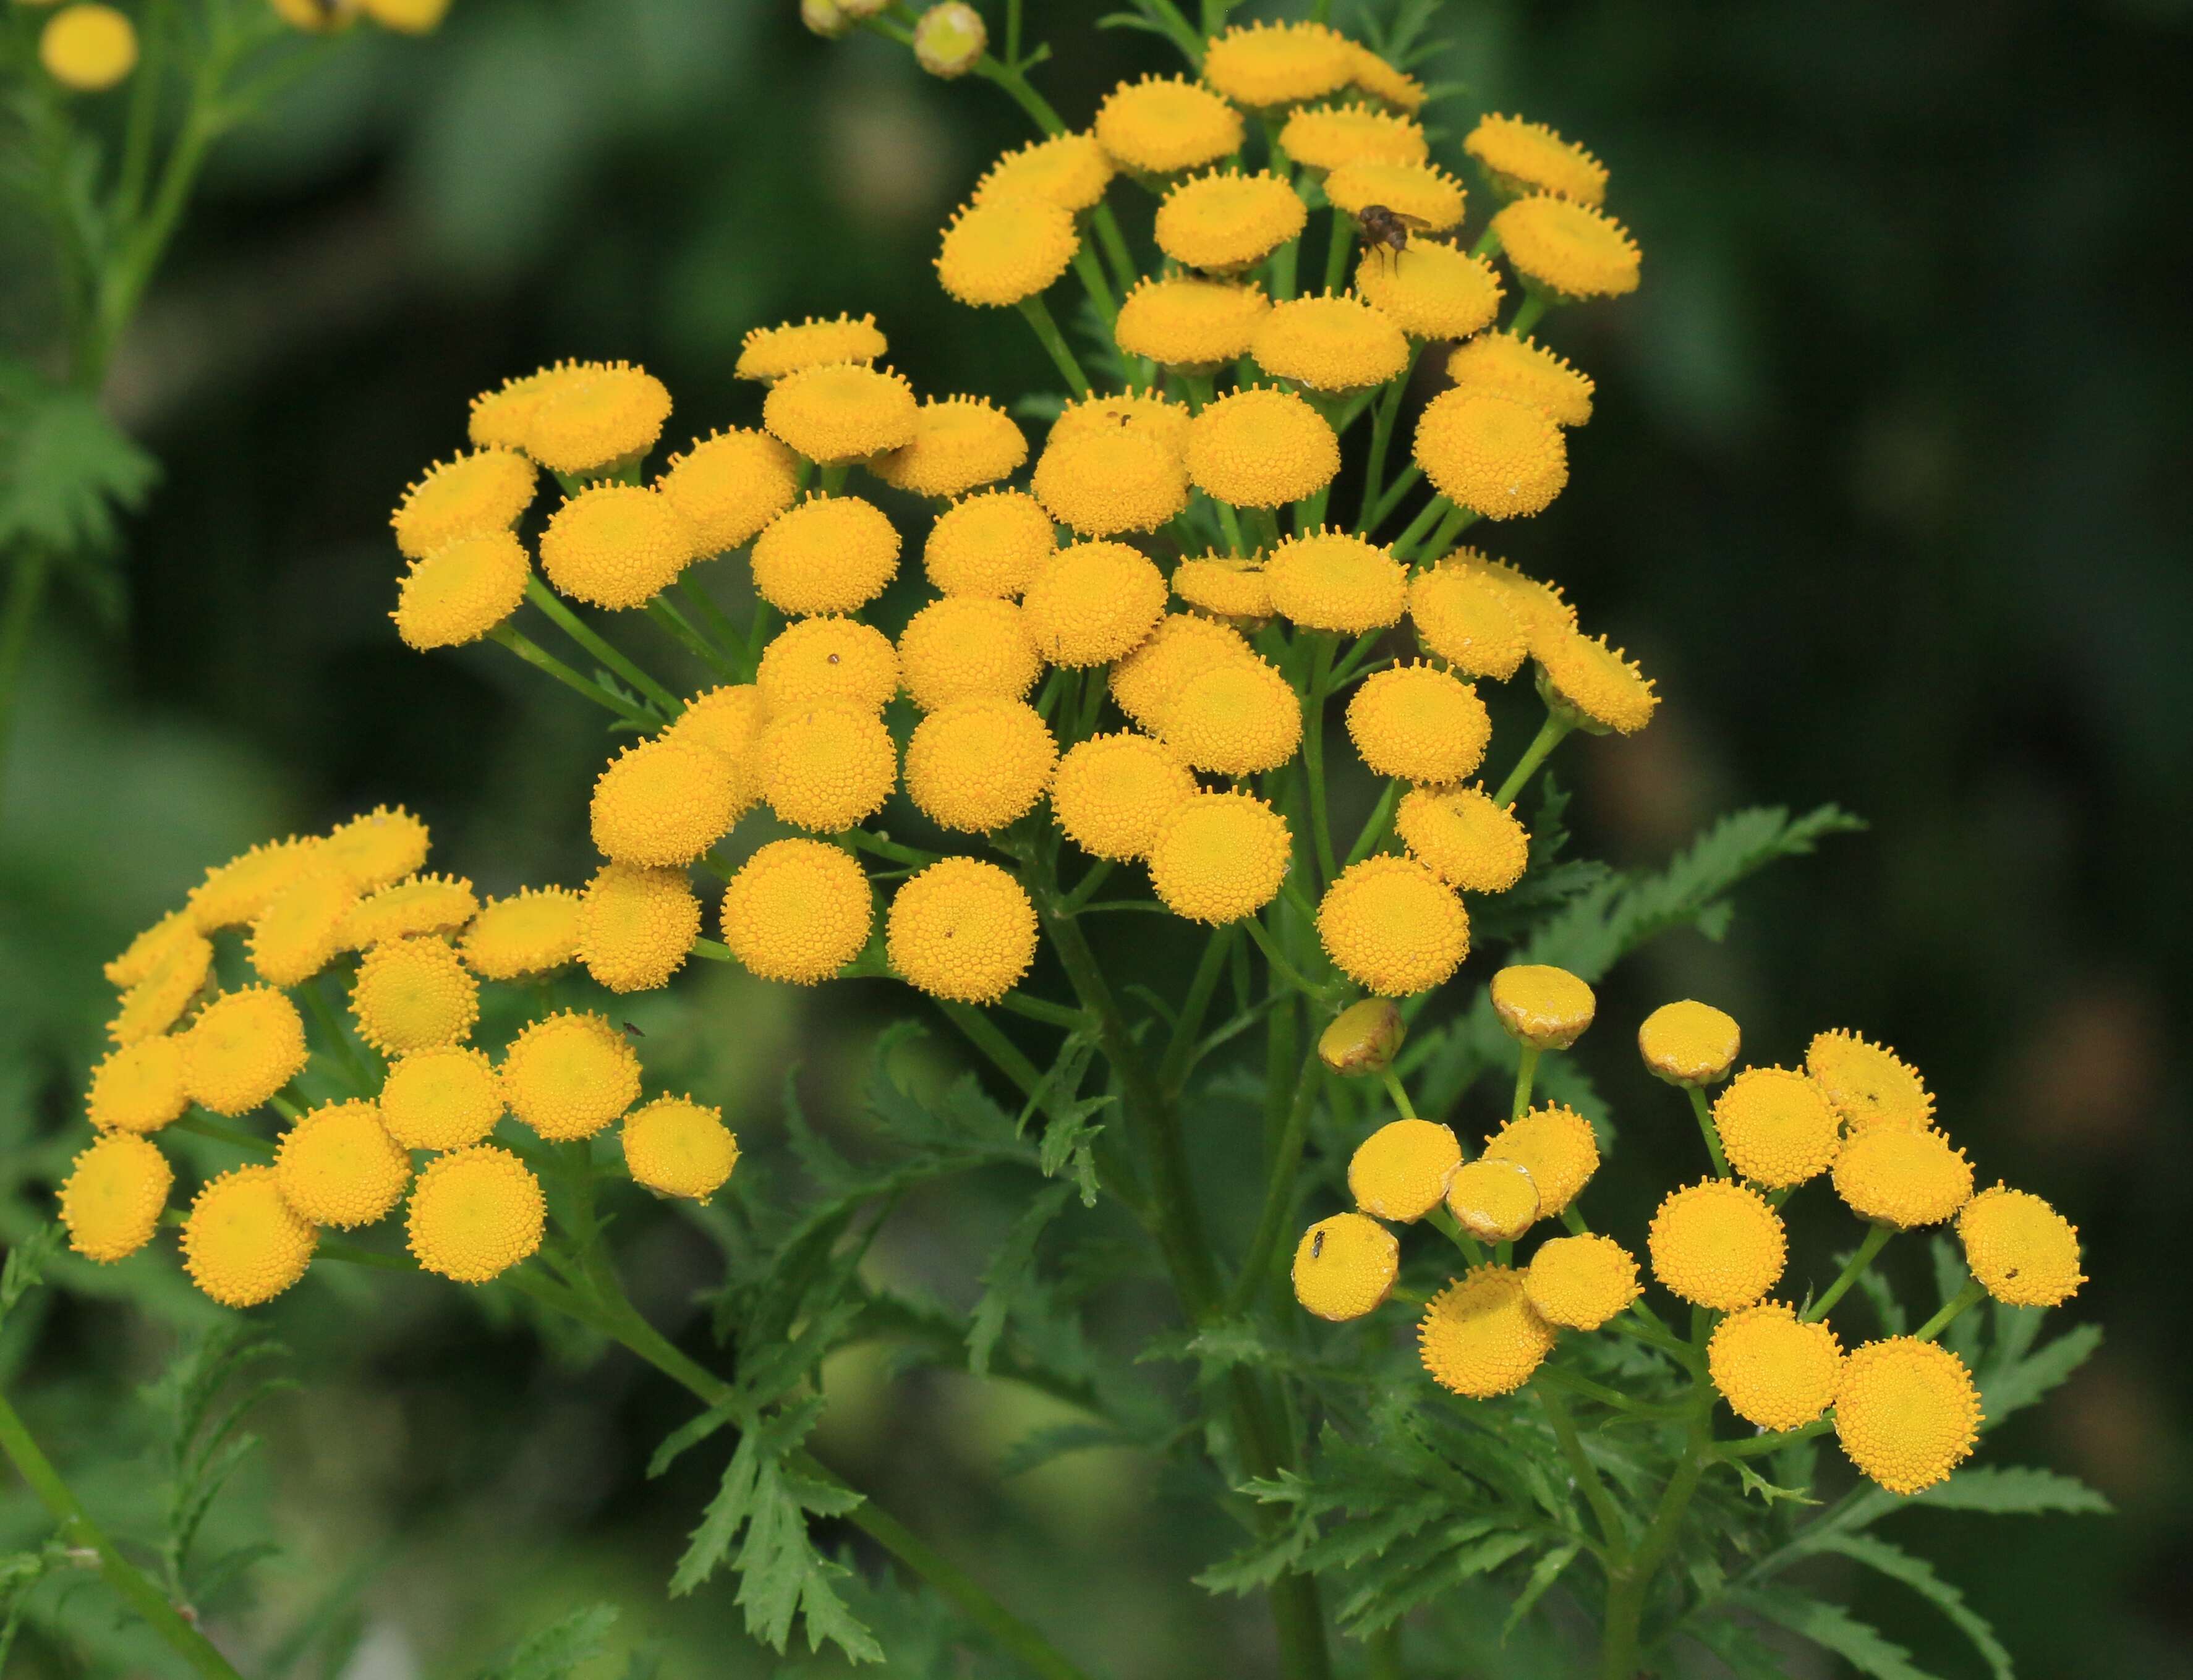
0;0;2193;1680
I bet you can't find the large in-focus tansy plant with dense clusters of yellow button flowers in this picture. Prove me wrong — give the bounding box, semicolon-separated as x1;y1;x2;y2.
17;0;2101;1680
